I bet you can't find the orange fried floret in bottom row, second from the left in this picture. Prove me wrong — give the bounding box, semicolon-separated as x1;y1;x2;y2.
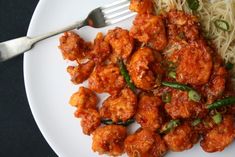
124;129;167;157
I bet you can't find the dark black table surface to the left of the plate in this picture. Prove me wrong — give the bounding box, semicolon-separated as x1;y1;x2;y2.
0;0;56;157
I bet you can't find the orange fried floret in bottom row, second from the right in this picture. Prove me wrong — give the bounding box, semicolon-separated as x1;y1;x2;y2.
163;123;199;152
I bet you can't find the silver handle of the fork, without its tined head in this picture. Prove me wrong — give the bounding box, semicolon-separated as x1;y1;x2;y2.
0;21;86;62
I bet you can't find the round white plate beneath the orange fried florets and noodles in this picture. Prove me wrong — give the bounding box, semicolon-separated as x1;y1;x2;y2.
24;0;235;157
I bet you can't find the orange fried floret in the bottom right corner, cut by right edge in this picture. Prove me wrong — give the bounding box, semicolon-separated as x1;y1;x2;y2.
200;115;235;153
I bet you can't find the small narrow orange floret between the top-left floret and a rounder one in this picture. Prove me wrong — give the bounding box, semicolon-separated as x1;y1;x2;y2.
91;33;111;63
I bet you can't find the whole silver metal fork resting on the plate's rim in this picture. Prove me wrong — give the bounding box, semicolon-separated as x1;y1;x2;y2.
0;0;136;62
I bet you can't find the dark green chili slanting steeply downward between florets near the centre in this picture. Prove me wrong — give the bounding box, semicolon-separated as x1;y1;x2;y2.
118;59;136;91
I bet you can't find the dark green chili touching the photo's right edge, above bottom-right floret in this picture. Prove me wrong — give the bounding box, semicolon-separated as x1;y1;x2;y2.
207;97;235;110
